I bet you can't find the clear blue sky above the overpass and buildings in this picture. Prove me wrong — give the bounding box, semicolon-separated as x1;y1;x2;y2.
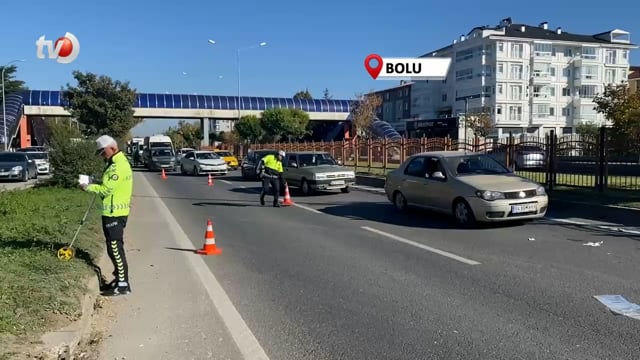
0;0;640;135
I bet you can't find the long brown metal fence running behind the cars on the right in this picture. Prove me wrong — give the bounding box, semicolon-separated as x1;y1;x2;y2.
228;128;640;192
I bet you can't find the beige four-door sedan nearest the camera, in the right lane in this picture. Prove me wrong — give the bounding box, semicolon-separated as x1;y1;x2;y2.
384;151;549;227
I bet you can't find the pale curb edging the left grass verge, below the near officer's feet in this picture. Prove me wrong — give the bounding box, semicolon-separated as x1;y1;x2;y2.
38;252;107;360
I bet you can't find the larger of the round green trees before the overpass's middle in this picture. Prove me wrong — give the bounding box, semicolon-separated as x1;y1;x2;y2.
260;108;309;142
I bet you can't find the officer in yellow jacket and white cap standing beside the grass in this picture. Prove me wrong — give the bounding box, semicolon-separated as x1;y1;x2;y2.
82;135;133;296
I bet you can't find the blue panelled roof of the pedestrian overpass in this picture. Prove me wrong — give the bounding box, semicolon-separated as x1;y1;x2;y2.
22;90;352;113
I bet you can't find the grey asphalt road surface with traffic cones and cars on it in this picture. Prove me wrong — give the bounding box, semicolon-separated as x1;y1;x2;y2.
143;169;640;360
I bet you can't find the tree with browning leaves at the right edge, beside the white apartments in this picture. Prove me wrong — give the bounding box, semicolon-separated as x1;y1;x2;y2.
593;83;640;141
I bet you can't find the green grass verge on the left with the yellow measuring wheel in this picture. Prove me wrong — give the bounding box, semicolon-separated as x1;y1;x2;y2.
0;187;103;359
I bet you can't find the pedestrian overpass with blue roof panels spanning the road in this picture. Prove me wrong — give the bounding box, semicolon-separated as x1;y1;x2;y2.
0;90;352;146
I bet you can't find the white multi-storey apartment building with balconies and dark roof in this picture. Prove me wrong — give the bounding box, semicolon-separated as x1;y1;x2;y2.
411;18;637;137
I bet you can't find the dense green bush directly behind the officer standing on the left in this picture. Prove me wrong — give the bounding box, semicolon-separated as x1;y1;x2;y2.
47;123;105;188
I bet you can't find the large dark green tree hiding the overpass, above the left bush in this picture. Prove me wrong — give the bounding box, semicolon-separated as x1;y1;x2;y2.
63;71;142;141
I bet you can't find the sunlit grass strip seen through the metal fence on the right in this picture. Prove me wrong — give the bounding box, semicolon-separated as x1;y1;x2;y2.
345;162;640;208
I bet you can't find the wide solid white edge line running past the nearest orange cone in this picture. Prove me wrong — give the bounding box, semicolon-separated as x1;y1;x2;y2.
139;176;269;360
